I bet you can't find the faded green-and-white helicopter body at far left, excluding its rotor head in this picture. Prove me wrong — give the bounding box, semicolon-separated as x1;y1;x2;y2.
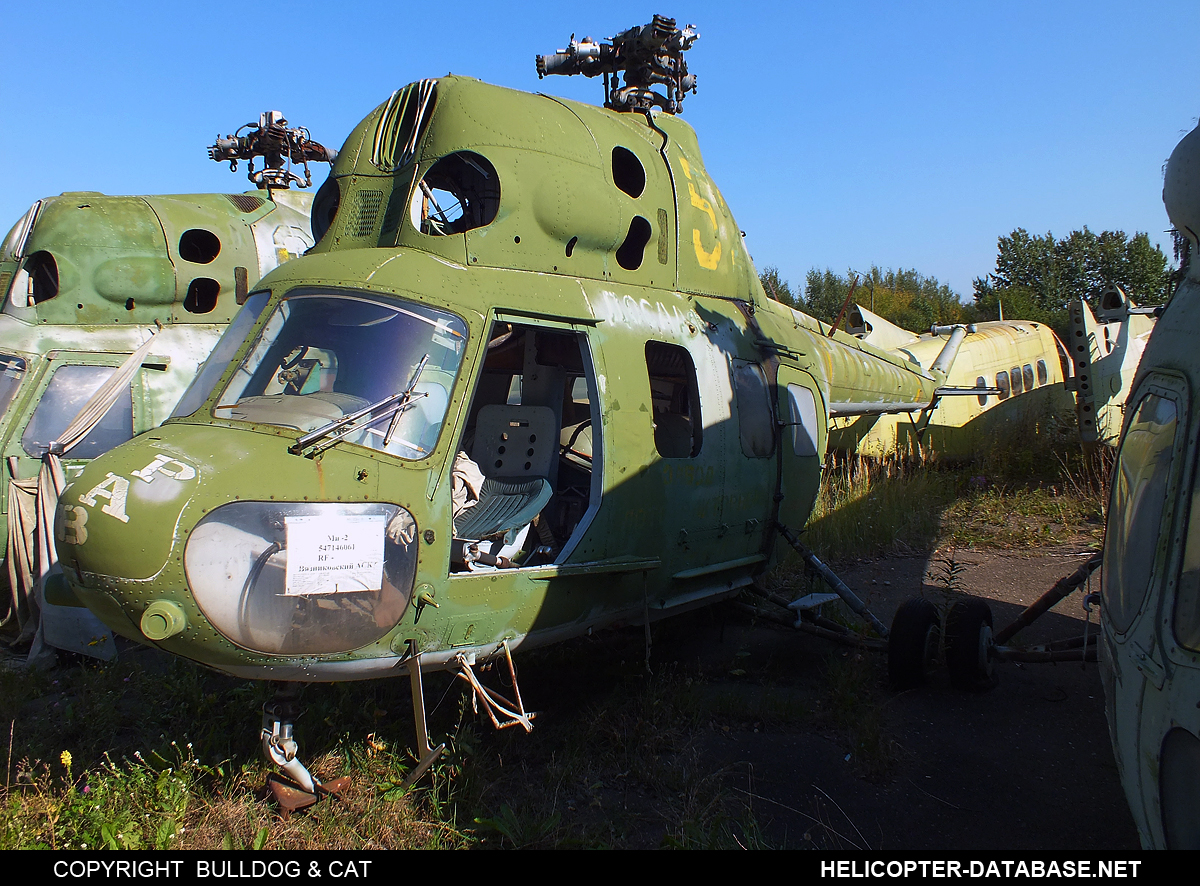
0;191;312;633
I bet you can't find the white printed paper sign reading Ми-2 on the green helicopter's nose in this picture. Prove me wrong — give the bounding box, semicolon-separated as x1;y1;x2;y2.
283;515;385;597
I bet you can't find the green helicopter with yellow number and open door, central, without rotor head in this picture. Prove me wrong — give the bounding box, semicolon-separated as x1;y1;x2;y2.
49;43;966;790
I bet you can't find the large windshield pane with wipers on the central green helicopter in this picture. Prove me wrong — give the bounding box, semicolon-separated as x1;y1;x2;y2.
212;289;467;459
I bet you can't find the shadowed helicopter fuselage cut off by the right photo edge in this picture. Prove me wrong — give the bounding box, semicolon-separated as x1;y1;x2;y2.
1100;118;1200;849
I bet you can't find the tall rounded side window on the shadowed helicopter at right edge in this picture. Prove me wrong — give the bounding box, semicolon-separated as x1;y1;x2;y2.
1104;394;1178;634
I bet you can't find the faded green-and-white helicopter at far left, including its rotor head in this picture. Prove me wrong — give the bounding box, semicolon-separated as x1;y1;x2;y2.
0;112;332;658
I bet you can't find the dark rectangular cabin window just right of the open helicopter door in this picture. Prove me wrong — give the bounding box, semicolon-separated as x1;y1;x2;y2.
646;341;703;459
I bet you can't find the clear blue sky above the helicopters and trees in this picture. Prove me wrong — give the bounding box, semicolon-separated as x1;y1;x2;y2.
0;0;1200;299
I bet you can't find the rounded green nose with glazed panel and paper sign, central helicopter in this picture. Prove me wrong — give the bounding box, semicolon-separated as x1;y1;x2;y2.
56;424;424;666
